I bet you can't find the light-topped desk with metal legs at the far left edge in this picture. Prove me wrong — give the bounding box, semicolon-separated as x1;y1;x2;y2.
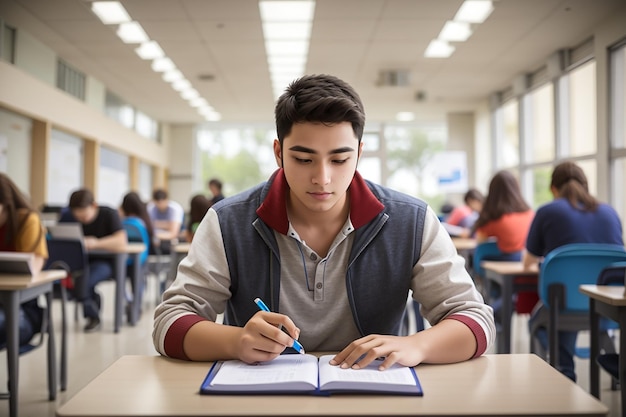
0;270;66;417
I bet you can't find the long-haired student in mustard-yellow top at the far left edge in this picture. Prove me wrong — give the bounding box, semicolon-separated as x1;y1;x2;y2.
0;173;48;346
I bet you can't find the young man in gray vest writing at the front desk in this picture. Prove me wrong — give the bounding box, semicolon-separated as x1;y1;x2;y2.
153;75;495;369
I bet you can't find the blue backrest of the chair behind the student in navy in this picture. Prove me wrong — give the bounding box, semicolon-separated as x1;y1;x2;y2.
539;243;626;313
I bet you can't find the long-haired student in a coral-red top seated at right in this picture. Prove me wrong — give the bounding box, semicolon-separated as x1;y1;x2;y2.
474;171;534;261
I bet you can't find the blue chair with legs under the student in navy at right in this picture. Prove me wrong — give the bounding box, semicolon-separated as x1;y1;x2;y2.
530;243;626;367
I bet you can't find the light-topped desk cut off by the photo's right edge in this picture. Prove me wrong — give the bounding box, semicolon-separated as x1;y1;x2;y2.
580;285;626;416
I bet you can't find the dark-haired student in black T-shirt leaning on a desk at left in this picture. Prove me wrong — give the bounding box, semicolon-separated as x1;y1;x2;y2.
59;188;127;333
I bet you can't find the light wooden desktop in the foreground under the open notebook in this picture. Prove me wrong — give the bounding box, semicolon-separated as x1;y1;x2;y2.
57;354;608;417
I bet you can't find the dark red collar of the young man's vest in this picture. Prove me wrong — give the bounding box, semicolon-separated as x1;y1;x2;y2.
256;168;385;235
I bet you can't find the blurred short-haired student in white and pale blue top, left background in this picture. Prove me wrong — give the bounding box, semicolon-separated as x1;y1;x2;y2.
148;188;185;253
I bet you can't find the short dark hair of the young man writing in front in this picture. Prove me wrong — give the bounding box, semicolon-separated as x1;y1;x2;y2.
274;74;365;147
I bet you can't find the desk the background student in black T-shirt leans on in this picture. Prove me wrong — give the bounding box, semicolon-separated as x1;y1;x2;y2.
88;242;146;333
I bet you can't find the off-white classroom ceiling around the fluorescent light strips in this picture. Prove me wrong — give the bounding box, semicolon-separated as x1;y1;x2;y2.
0;0;626;123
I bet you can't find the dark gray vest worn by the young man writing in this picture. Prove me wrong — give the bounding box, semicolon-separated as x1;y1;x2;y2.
213;176;427;336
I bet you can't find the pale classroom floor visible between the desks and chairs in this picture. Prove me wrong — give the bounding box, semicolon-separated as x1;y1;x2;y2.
0;280;620;417
